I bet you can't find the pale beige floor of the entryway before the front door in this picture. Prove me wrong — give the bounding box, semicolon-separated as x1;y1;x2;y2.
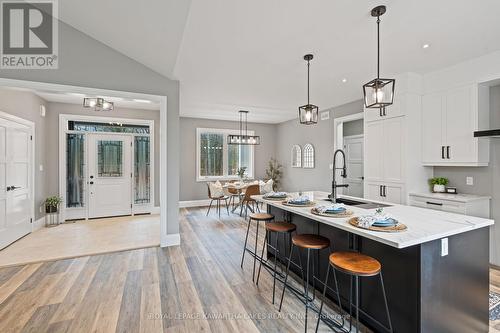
0;215;160;267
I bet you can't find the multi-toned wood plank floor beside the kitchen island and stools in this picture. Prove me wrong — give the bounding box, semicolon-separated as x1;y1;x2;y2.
0;208;494;332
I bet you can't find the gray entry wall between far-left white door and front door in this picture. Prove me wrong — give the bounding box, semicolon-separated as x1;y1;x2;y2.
0;88;47;219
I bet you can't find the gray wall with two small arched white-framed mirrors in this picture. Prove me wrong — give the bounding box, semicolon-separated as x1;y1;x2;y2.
276;100;363;191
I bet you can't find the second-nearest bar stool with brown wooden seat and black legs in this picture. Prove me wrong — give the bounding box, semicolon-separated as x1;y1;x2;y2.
279;234;331;332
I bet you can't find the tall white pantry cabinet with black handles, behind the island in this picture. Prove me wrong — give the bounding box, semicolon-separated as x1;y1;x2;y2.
364;73;432;204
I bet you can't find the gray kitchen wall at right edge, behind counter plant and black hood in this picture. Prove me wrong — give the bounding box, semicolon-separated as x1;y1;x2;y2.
434;86;500;265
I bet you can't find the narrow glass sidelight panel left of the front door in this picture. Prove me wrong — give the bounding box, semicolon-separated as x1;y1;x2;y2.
66;134;85;207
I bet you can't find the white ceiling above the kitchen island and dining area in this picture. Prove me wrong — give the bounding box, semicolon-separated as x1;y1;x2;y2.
59;0;500;123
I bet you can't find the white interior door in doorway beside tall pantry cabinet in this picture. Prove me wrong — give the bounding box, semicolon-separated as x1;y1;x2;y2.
344;135;364;198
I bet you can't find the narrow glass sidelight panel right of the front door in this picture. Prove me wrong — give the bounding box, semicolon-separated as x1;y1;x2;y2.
134;136;151;204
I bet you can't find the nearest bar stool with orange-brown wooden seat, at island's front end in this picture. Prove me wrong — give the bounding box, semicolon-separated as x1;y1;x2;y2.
316;252;392;332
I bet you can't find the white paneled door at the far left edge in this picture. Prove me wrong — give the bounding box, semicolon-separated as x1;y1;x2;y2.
0;117;33;249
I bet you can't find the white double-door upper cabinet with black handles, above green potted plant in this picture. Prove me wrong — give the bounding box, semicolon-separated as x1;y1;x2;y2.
422;84;489;166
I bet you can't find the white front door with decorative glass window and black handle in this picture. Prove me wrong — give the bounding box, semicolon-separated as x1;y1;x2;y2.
88;134;132;218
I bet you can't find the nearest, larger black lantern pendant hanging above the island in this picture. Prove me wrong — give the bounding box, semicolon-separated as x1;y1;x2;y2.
363;6;396;109
